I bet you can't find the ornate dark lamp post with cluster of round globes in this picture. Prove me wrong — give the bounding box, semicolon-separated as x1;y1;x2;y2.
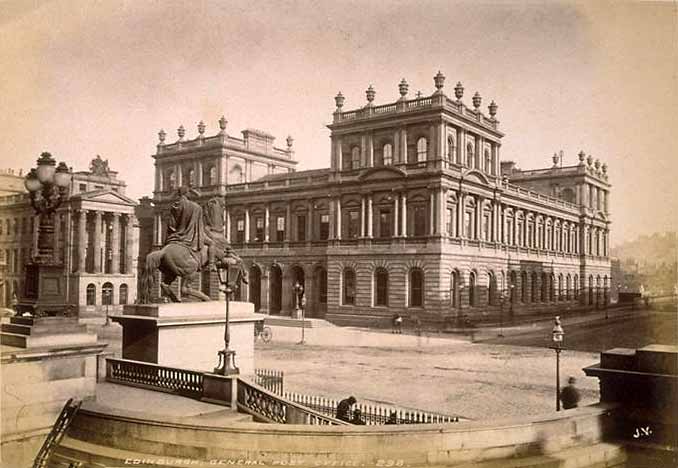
24;152;72;315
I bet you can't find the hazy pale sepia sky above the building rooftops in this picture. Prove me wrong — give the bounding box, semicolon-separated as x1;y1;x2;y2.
0;0;678;245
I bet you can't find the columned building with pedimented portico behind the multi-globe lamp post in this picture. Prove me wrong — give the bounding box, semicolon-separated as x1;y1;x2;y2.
0;156;138;316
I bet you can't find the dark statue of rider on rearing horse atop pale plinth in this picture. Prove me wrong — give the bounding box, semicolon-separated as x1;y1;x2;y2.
139;187;247;304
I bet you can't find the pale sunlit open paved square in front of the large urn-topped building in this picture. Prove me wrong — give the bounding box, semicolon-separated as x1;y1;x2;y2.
255;327;599;419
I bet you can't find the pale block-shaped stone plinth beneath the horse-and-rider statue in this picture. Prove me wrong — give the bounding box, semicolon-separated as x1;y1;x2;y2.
112;301;264;375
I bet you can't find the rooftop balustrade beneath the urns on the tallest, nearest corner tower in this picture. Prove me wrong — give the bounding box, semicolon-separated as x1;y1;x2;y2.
334;94;499;131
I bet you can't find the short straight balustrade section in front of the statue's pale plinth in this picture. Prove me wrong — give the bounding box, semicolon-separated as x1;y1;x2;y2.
106;358;203;398
